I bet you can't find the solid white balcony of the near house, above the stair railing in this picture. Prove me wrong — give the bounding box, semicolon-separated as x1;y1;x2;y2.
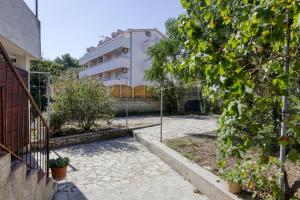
0;0;41;58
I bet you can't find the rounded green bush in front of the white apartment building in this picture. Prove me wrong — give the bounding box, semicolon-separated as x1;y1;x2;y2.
52;70;115;130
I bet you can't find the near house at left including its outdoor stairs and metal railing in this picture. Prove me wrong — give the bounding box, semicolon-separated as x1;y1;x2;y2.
0;0;53;200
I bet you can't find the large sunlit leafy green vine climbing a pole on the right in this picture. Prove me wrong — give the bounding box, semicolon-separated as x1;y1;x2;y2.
173;0;300;199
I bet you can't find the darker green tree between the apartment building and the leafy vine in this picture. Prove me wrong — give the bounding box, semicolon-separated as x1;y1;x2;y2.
145;18;192;113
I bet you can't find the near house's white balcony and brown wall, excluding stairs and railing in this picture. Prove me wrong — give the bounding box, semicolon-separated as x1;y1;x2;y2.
0;0;41;148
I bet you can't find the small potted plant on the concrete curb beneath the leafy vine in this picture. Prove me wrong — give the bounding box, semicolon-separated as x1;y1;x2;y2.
224;169;242;194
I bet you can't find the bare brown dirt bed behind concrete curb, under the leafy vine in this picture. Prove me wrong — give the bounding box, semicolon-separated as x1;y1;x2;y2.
165;135;300;198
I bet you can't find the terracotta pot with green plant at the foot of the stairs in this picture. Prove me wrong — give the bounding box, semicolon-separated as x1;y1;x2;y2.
49;157;70;181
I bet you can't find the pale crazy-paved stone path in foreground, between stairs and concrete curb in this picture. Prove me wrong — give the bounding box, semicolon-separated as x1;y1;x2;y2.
51;138;207;200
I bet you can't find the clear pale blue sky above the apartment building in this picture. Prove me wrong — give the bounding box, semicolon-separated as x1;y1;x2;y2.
25;0;184;59
